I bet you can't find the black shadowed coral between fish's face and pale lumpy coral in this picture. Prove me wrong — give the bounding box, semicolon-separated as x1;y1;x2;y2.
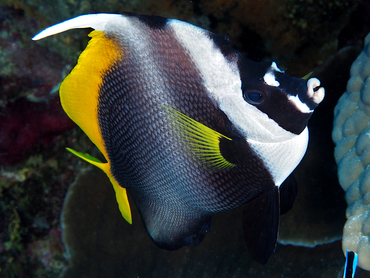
279;46;362;247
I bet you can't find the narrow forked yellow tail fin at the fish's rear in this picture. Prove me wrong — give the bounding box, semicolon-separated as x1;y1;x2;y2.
67;148;132;224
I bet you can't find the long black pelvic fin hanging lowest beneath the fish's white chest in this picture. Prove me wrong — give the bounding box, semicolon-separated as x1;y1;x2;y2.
243;186;280;264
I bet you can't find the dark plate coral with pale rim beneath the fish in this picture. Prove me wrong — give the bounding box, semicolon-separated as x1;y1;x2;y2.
62;169;352;278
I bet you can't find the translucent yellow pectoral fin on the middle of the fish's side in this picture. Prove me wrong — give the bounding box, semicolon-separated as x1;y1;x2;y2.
163;105;235;171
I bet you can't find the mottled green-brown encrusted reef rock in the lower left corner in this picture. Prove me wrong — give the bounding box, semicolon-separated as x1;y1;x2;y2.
0;129;91;277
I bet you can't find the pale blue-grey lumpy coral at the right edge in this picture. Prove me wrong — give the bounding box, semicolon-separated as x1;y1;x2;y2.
332;31;370;270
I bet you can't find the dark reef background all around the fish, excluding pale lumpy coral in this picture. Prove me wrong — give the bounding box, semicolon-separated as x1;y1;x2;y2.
0;0;370;278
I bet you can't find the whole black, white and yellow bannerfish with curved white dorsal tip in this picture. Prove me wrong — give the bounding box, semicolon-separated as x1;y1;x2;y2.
33;13;324;264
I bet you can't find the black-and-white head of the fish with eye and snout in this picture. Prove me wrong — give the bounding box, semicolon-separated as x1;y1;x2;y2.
220;57;325;146
